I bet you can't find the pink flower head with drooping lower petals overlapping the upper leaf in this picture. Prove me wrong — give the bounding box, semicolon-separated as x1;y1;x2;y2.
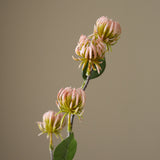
72;35;106;73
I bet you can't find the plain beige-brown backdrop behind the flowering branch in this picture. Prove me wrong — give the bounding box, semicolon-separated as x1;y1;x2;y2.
0;0;160;160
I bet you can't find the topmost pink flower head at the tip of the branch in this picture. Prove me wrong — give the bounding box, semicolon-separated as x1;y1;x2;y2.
94;16;121;48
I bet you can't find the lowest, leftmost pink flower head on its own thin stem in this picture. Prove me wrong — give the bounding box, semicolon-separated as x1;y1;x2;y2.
37;111;66;135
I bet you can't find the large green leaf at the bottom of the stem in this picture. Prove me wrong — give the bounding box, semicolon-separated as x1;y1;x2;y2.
54;133;77;160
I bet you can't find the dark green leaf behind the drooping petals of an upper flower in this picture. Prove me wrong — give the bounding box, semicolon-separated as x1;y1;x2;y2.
82;58;106;80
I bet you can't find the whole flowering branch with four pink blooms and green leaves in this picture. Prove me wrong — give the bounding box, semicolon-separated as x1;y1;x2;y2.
37;16;121;160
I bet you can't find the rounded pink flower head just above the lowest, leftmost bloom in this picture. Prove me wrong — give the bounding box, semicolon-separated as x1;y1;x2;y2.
56;87;86;117
